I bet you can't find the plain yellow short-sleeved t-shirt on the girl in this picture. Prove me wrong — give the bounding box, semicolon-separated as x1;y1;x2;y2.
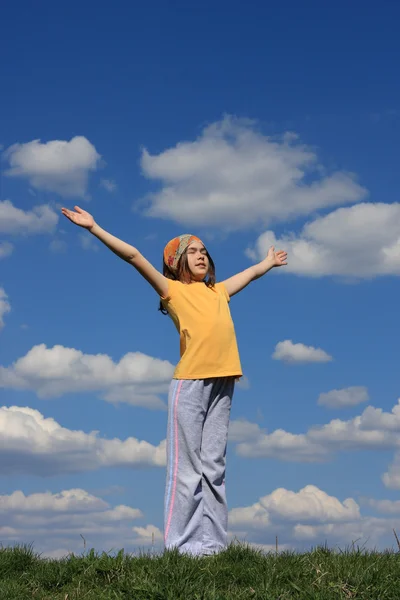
161;279;242;379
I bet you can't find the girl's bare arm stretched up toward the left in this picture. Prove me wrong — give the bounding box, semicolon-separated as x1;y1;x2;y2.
62;206;168;297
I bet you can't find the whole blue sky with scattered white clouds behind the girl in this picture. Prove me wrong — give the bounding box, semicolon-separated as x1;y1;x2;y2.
0;0;400;556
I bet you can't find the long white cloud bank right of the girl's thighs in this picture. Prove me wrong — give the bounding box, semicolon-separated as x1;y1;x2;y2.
232;399;400;462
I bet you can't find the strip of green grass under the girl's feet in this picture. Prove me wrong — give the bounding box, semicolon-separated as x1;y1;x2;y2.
0;544;400;600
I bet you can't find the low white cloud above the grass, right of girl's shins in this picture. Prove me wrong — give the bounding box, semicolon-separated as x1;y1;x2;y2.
229;485;400;551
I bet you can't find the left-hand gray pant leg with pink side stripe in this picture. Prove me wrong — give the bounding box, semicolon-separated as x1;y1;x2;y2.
164;379;208;554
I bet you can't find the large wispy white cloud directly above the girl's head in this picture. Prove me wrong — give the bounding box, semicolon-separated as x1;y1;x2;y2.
141;117;366;230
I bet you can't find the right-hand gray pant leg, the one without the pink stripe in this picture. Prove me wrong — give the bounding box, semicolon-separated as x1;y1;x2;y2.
200;377;235;554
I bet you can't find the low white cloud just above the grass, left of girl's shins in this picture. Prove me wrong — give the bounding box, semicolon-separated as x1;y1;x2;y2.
0;489;162;558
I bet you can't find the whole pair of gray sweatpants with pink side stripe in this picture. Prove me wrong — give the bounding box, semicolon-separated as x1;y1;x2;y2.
164;377;235;555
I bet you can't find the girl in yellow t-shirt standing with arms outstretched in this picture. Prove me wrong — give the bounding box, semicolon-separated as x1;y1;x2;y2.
62;206;287;555
